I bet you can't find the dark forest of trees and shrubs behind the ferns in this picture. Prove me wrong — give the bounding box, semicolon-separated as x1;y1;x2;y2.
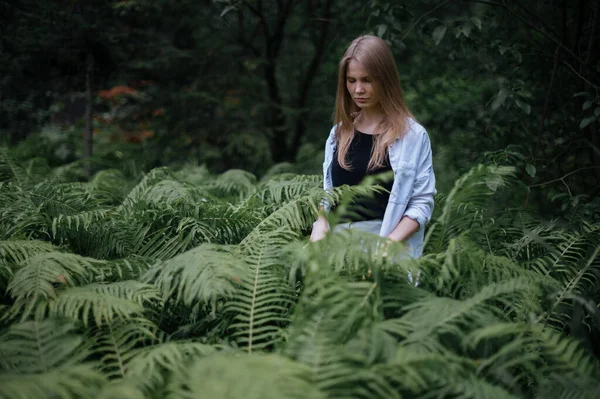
0;0;600;216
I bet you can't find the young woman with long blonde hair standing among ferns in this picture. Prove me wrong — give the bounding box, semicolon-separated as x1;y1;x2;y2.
310;36;436;258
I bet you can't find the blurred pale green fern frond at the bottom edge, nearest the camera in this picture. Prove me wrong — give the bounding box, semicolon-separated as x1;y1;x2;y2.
169;353;325;399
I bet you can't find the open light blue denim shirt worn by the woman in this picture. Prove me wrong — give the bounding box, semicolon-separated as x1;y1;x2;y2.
323;118;437;258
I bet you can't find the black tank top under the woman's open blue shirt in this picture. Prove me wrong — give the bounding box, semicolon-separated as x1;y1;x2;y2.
331;130;394;223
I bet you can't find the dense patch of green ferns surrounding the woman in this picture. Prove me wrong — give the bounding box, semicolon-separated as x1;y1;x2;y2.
0;151;600;399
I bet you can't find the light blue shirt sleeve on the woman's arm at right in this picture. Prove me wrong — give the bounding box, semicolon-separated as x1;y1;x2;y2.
404;132;437;229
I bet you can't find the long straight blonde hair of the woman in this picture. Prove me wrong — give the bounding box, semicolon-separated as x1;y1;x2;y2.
334;35;413;170
